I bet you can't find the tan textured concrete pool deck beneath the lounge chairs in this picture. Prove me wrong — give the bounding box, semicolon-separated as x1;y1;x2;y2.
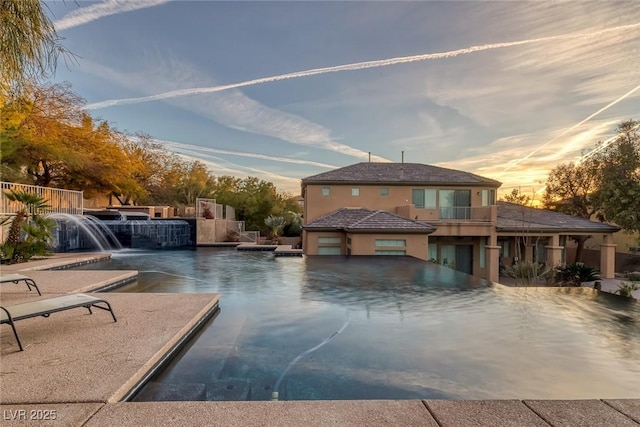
0;254;640;427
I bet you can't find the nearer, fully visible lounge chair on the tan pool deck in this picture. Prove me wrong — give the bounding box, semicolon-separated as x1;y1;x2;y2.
0;294;117;351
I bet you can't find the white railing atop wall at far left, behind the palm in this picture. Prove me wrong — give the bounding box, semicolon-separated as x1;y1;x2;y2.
0;182;84;215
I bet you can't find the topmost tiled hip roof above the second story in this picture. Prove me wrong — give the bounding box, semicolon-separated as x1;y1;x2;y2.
302;162;501;188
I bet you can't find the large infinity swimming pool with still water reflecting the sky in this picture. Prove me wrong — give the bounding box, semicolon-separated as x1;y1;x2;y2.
72;248;640;400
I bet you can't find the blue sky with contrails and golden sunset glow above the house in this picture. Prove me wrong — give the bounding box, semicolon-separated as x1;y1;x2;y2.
47;0;640;199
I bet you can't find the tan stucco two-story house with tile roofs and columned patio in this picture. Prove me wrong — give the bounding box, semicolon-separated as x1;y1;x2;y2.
302;162;619;281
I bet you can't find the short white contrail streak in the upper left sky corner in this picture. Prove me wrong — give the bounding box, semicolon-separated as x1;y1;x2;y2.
53;0;169;31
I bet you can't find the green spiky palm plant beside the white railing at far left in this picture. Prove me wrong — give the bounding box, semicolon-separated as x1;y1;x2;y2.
0;190;55;264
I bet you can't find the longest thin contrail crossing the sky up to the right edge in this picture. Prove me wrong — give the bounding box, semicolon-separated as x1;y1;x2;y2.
85;23;640;110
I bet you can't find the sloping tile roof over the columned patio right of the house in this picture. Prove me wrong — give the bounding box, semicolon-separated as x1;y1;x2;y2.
496;202;620;233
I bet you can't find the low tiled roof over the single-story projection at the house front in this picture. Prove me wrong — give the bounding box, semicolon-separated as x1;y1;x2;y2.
303;208;436;234
